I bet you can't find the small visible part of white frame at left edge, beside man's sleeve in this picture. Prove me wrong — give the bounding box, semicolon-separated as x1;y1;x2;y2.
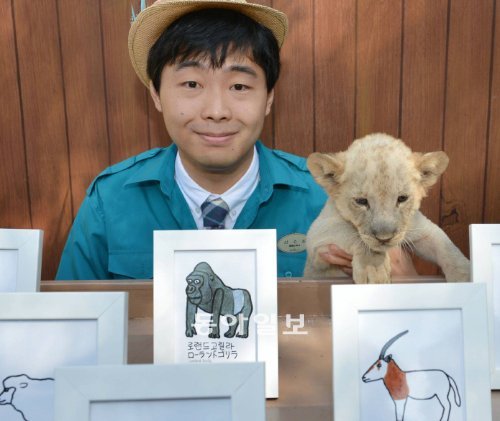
0;229;43;292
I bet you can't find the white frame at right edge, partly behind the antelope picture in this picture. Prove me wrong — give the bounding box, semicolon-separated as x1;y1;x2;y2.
469;224;500;390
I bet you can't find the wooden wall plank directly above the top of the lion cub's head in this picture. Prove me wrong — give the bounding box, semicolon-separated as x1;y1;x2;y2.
356;0;402;137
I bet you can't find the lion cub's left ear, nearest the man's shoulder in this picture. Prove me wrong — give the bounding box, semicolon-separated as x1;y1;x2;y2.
307;152;345;192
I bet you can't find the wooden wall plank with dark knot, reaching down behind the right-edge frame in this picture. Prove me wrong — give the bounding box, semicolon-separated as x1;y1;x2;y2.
441;0;493;254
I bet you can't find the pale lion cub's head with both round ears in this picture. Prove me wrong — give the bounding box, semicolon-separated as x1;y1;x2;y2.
307;134;448;251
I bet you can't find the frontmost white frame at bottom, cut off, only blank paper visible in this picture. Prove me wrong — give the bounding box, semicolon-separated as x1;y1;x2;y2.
55;363;266;421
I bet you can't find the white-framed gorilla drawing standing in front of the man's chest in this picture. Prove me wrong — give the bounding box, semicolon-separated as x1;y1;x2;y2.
154;230;278;398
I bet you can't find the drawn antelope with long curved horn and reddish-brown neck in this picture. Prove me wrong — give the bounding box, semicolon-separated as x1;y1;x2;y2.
362;330;461;421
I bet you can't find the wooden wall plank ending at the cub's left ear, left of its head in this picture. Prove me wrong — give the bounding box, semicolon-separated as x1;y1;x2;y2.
314;0;356;152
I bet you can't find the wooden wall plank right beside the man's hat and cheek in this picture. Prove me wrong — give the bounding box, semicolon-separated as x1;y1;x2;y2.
273;0;315;156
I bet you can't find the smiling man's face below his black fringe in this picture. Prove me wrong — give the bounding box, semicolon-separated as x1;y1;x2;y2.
151;54;273;185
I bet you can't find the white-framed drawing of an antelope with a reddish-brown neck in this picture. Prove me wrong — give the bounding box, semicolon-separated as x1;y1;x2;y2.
332;283;491;421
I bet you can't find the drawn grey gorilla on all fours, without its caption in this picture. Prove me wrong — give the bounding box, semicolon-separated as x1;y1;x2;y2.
186;262;253;338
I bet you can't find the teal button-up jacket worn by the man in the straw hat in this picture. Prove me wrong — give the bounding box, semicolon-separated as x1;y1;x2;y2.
56;142;326;279
